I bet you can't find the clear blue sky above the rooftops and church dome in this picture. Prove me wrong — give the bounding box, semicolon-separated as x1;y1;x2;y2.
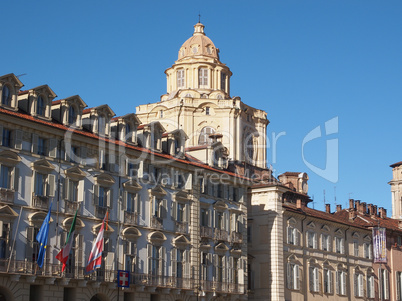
0;0;402;215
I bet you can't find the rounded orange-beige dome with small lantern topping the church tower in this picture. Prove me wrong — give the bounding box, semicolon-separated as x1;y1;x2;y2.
179;23;219;60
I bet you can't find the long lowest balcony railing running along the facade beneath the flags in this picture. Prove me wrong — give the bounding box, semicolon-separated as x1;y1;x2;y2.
0;259;244;294
